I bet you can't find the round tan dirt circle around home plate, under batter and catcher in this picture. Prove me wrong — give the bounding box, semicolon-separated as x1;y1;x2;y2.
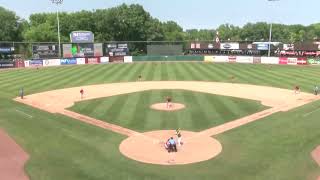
119;130;222;165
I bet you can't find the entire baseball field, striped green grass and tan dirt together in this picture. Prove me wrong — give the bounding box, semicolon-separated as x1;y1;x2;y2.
0;62;320;180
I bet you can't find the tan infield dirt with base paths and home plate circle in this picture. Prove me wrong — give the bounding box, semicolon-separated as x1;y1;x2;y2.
15;81;319;165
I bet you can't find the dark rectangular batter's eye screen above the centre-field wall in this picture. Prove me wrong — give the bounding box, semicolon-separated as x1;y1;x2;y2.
147;45;183;56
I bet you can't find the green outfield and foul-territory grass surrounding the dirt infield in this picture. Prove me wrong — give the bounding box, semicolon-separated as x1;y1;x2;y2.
0;63;320;180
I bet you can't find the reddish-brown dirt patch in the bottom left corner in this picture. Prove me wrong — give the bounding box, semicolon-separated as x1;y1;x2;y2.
0;129;29;180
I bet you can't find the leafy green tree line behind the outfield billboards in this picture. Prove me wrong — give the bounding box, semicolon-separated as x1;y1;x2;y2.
0;4;320;43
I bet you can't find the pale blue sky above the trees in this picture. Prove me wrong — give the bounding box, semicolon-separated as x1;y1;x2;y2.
0;0;320;29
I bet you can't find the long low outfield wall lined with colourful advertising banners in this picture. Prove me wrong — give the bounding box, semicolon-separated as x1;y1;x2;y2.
0;56;320;68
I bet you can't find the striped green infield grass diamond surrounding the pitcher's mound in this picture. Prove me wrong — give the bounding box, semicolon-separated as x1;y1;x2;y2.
70;90;267;132
